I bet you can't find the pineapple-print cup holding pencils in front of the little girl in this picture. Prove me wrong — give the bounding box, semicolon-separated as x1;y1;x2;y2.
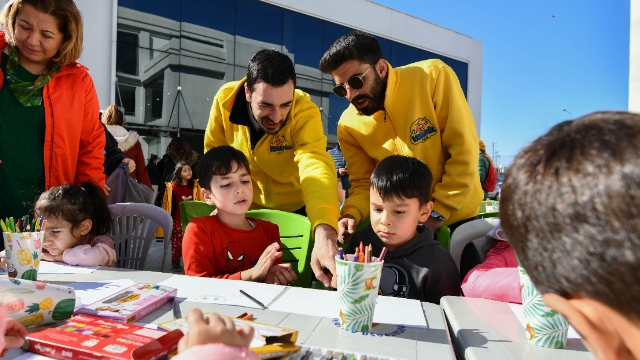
2;231;44;280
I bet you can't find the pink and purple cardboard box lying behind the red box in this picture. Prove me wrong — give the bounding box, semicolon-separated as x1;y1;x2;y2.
75;283;178;323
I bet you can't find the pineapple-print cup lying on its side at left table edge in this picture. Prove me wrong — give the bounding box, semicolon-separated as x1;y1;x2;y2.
0;277;76;326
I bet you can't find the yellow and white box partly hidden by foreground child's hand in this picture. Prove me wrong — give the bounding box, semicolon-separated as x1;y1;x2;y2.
158;316;300;359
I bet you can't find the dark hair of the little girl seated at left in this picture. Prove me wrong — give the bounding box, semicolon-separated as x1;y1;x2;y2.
35;181;111;235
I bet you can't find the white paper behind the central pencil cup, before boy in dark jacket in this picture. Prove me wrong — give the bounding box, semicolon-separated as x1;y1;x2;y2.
269;288;429;327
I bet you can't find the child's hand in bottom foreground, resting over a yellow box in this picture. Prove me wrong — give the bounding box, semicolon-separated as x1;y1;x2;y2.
178;309;253;353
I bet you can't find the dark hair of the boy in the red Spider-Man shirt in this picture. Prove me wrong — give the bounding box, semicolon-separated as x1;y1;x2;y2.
198;145;251;191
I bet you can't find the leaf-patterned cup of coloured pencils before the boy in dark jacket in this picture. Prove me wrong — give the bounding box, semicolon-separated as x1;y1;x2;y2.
336;255;384;332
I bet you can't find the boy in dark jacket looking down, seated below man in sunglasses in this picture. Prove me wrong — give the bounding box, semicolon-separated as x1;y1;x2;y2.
346;155;460;304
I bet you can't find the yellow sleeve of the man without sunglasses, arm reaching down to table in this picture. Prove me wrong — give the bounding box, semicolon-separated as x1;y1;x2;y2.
291;94;340;232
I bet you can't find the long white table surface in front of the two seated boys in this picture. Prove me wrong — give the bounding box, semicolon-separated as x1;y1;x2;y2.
6;268;455;360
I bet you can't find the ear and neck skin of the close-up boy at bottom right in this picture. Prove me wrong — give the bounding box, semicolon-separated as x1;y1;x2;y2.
542;294;640;359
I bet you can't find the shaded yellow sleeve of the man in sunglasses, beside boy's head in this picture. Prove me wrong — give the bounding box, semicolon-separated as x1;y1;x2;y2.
338;121;376;228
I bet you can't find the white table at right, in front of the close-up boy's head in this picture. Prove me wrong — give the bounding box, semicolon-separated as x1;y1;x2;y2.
440;296;594;360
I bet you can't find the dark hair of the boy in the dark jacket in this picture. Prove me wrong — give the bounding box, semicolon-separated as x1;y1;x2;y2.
369;155;433;206
